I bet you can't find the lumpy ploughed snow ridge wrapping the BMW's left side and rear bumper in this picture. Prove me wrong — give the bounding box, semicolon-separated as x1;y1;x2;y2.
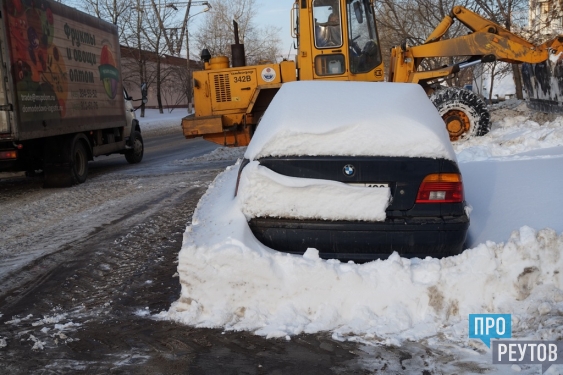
166;167;563;345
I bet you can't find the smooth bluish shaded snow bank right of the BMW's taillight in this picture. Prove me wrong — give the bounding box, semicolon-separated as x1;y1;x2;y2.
454;100;563;246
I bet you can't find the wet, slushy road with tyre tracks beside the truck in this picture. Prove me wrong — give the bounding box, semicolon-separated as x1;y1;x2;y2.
0;133;382;374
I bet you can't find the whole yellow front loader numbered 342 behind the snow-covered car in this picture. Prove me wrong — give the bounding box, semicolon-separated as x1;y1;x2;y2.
182;0;563;146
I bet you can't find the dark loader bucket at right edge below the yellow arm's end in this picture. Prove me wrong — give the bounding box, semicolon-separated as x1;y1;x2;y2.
521;53;563;113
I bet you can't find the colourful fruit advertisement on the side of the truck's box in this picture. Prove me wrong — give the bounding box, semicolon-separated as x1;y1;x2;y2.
3;0;124;139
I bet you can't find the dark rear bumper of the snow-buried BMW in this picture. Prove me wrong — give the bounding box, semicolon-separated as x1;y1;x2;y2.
248;216;469;260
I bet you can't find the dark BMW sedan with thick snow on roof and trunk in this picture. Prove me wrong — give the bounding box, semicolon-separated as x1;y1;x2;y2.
235;81;469;260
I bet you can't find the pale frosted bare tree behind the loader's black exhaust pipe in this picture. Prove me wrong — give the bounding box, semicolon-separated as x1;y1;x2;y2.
194;0;281;64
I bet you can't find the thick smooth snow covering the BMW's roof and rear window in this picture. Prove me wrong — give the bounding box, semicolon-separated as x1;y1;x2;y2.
245;81;456;161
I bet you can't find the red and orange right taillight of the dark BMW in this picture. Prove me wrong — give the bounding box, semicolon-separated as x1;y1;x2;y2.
416;173;463;203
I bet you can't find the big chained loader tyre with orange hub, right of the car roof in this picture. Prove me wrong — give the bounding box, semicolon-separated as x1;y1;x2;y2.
430;87;491;141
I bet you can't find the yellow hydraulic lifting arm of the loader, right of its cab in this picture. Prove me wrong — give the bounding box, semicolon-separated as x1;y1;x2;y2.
389;6;563;83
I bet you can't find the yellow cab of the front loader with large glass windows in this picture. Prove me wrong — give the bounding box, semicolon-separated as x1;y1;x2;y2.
293;0;384;81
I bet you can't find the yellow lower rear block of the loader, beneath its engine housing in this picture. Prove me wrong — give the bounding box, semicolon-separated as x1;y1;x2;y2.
182;115;252;147
